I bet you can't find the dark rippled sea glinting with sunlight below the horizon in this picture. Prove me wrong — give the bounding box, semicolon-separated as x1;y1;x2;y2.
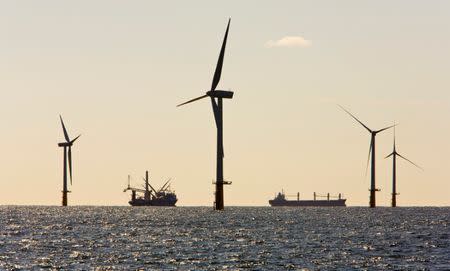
0;206;450;270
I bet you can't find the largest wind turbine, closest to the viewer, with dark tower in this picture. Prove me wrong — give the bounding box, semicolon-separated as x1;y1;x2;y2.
177;19;233;210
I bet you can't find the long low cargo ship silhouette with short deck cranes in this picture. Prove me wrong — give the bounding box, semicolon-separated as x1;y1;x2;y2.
269;191;347;207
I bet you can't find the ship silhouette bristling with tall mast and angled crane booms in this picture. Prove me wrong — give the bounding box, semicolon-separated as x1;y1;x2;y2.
123;171;178;206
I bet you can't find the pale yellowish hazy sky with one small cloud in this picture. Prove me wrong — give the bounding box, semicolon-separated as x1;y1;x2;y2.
0;0;450;206
